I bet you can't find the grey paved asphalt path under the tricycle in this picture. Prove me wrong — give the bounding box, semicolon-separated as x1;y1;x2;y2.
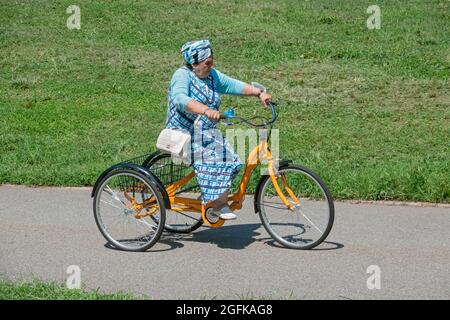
0;185;450;299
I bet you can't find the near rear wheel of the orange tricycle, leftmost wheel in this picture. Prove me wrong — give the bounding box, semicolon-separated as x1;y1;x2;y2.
93;168;166;251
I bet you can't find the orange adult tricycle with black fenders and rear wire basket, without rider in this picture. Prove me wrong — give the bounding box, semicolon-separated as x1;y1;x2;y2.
92;102;334;251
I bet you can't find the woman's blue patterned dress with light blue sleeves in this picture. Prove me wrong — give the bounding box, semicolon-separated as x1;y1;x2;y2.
166;67;245;204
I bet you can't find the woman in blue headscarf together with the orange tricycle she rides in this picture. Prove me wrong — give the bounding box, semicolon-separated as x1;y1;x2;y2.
92;40;334;251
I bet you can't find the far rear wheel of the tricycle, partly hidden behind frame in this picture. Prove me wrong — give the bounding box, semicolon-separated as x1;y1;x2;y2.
143;152;203;233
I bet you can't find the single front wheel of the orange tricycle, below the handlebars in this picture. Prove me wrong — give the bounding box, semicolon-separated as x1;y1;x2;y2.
255;165;334;249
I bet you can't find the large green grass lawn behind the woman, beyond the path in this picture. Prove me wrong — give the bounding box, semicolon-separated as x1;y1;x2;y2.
0;0;450;202
